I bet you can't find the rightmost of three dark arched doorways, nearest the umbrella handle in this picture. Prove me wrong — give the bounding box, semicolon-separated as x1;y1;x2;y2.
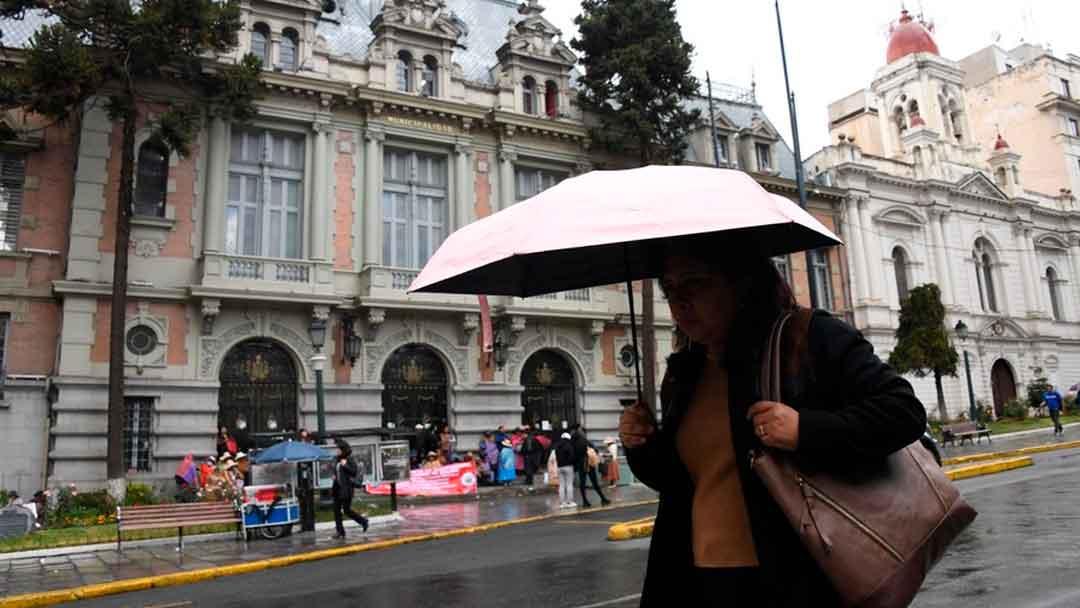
522;350;578;431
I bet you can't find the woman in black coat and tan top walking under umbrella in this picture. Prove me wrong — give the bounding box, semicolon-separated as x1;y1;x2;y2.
619;239;926;608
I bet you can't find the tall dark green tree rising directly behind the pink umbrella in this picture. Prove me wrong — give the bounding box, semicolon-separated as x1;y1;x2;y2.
570;0;700;408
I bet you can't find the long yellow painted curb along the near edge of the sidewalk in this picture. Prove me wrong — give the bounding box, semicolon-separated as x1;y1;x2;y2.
0;500;659;608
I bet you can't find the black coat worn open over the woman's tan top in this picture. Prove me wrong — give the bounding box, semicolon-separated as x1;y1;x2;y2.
626;312;926;608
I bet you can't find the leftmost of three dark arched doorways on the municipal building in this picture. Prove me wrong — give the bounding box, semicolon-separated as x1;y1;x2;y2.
217;338;299;448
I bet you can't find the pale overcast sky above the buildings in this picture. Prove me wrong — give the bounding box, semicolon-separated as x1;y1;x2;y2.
542;0;1080;158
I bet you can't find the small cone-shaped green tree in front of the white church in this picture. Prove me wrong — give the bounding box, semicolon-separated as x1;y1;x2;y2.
889;283;960;421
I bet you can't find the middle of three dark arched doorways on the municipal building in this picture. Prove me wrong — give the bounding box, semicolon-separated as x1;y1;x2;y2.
382;344;448;429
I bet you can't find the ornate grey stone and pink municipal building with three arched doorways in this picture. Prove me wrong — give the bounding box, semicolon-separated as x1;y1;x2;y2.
0;0;850;490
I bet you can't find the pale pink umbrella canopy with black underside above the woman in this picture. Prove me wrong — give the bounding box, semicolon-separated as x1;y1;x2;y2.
409;166;840;297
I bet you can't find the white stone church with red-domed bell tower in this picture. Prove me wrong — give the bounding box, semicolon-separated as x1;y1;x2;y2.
806;12;1080;417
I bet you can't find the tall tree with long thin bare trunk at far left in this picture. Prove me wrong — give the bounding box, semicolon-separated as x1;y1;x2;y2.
0;0;261;494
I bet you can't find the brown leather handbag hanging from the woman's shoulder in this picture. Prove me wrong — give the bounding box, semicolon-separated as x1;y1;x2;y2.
751;314;976;608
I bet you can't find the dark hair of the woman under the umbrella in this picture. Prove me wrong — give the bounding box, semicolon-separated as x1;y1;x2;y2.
664;237;798;356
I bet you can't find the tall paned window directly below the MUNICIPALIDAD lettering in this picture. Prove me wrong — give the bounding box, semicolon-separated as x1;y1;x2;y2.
382;148;448;268
